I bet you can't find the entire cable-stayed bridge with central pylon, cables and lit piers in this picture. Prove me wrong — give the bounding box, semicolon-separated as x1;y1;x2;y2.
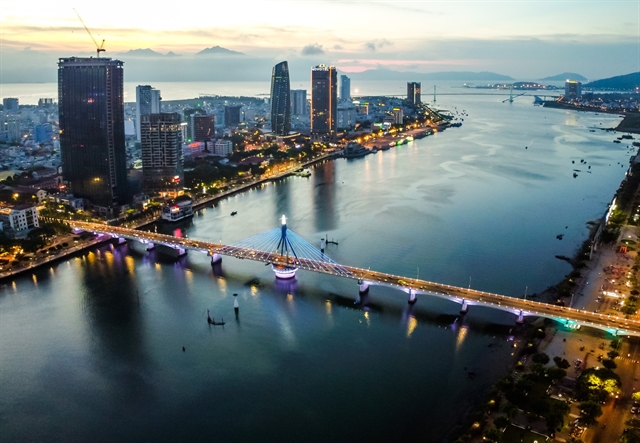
69;220;640;336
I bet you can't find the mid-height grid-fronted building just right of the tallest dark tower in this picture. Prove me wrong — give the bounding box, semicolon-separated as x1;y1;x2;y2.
140;113;184;197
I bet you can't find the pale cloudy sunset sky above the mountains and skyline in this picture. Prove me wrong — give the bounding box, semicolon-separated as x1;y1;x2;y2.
0;0;640;83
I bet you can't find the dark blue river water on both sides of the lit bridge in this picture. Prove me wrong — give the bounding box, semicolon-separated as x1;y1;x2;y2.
0;92;629;442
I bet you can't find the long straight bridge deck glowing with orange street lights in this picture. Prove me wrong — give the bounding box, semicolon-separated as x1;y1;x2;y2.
70;221;640;335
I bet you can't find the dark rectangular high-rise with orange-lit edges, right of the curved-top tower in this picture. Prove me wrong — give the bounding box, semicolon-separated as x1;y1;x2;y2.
311;65;338;136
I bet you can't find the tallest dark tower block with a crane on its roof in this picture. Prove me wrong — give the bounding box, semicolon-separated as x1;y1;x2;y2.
58;57;129;208
